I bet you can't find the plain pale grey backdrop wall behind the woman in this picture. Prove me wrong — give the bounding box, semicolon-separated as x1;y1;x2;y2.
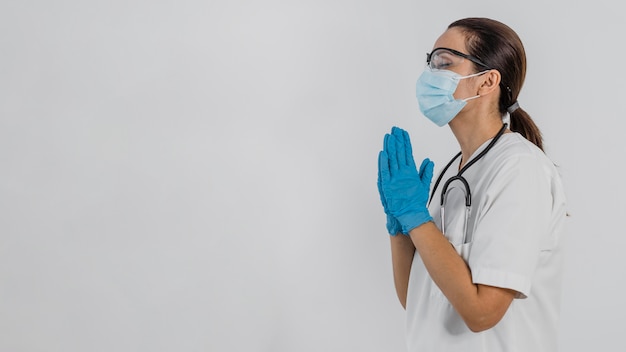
0;0;626;352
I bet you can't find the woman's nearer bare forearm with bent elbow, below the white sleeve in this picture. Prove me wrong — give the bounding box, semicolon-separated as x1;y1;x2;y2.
410;222;515;331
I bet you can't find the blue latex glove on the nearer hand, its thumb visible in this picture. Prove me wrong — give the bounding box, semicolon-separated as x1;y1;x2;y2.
378;127;434;233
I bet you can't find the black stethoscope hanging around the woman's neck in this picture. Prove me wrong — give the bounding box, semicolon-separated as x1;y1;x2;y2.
428;123;508;243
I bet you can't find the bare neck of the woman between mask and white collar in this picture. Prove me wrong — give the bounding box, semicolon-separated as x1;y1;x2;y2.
449;116;502;169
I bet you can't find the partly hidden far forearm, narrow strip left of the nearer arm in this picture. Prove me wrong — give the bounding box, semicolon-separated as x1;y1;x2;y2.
389;234;415;308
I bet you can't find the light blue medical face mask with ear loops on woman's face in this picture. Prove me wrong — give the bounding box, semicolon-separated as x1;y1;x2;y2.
415;68;488;127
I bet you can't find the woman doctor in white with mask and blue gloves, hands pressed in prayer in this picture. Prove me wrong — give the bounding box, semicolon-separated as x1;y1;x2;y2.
378;18;566;352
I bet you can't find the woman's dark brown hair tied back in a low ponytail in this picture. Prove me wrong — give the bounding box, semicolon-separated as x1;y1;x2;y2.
448;17;543;150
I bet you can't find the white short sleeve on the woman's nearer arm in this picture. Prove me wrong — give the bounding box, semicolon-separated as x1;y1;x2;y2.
468;154;551;298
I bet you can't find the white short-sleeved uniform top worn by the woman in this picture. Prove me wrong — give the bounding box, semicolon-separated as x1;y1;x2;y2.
406;133;566;352
